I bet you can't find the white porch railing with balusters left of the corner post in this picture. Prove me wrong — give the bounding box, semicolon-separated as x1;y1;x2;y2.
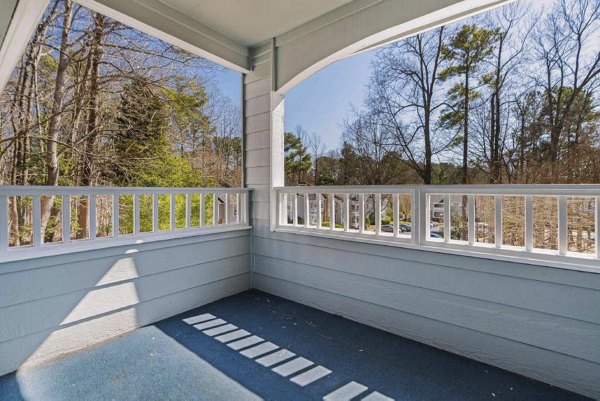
0;186;248;255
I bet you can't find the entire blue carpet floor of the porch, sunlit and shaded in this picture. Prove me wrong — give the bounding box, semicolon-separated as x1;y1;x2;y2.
0;291;585;401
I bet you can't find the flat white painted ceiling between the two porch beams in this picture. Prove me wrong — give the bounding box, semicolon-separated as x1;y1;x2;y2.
160;0;352;46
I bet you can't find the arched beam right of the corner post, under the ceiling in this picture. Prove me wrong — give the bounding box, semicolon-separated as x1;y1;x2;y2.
270;0;514;93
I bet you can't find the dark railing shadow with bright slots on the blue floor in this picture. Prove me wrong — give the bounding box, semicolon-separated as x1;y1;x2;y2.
156;291;585;400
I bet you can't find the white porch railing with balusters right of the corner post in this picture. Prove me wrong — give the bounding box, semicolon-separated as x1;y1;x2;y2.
276;185;600;267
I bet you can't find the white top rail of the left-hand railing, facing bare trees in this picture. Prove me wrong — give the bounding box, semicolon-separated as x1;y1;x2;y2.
0;185;250;196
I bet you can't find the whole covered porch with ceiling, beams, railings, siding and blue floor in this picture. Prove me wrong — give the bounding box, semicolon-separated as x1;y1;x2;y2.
0;0;600;400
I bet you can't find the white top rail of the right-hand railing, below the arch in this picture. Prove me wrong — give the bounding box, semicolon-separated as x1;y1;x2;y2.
275;184;600;196
